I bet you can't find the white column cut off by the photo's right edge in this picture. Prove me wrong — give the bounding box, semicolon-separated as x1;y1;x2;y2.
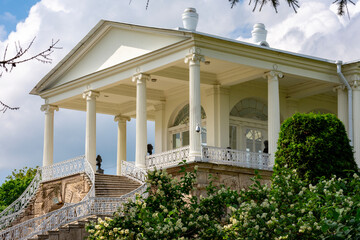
352;80;360;168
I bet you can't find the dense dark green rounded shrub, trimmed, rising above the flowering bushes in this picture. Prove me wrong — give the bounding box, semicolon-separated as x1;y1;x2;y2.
274;113;357;183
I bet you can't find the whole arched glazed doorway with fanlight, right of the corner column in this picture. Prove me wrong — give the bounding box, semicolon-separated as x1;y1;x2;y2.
229;98;268;152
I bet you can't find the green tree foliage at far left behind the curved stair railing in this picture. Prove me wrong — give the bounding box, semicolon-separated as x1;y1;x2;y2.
0;167;37;211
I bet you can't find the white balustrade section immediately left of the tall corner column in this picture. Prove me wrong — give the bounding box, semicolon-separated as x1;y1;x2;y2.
146;146;189;169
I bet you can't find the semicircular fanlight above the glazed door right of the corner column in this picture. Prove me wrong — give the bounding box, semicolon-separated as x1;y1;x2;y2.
230;98;268;121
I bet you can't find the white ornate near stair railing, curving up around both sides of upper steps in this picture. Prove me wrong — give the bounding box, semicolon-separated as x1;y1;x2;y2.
0;159;147;240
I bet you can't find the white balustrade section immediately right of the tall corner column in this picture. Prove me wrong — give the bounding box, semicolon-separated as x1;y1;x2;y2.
201;146;271;170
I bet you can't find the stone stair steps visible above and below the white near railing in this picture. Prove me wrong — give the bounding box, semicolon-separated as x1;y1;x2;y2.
26;174;141;240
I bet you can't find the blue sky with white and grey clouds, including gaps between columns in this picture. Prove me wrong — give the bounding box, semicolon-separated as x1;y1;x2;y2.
0;0;360;183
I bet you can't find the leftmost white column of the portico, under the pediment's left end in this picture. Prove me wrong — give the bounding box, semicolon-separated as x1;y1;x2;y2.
40;104;59;167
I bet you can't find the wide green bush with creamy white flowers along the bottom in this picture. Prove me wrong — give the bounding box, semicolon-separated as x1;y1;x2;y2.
87;166;360;240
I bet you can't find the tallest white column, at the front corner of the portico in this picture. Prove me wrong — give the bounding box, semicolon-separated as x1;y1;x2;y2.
185;48;205;159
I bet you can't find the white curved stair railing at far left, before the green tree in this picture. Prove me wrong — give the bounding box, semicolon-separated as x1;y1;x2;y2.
0;168;41;229
